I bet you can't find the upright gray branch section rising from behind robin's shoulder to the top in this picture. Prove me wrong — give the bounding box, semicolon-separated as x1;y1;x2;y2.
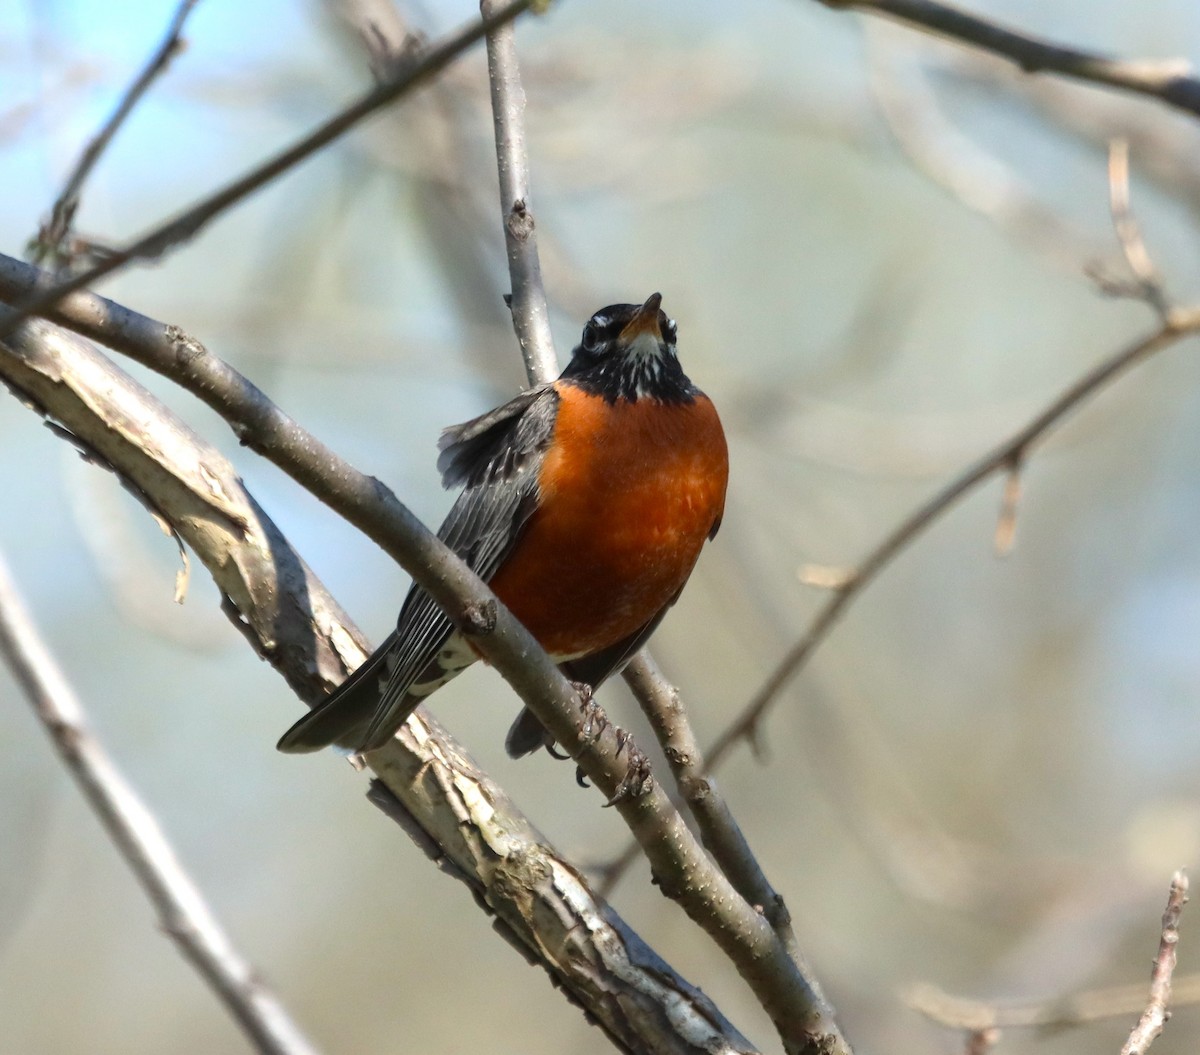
479;0;558;384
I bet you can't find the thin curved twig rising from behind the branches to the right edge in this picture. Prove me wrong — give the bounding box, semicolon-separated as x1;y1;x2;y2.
708;307;1200;771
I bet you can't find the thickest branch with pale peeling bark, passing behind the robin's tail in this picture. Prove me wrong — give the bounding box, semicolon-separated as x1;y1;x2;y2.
0;316;755;1055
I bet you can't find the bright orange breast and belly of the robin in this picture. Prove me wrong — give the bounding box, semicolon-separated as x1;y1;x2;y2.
491;382;728;660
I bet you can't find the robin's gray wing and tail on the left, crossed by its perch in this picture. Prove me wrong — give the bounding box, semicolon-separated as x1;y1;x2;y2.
280;385;558;751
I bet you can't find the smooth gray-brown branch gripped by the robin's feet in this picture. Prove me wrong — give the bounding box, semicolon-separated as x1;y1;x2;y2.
0;257;850;1055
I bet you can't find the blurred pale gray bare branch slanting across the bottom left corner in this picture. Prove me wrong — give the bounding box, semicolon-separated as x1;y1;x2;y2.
0;557;316;1055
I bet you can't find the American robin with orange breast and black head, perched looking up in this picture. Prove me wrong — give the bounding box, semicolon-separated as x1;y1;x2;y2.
278;293;728;757
